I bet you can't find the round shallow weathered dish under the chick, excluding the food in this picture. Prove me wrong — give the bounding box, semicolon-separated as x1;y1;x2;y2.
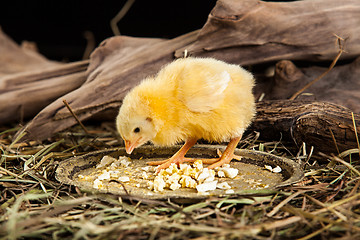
56;145;304;200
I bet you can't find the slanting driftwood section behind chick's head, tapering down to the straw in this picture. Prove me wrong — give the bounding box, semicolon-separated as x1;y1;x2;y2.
14;32;196;140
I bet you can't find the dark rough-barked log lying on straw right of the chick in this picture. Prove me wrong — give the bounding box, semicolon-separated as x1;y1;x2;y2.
251;100;360;154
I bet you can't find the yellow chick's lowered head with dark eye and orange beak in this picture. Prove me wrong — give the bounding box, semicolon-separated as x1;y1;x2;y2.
116;91;157;154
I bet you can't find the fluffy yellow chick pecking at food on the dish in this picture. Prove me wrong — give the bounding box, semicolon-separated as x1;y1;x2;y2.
116;58;255;171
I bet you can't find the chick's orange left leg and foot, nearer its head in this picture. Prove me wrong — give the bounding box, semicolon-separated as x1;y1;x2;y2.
147;138;197;172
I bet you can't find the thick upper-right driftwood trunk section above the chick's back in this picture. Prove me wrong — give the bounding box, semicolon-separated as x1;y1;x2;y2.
175;0;360;65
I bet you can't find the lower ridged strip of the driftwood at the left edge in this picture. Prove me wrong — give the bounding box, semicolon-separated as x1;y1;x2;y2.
0;61;87;124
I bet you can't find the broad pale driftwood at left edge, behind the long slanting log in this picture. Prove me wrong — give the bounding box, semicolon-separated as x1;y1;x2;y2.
0;29;88;124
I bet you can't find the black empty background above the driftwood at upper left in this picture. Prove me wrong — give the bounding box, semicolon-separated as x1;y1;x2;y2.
0;0;216;61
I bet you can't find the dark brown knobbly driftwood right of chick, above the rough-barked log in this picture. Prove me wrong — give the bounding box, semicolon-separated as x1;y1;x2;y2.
265;57;360;113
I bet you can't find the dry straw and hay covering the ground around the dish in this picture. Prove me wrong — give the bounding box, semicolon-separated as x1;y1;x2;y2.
0;124;360;239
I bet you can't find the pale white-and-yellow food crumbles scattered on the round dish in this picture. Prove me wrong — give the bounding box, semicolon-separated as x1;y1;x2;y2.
90;156;242;195
